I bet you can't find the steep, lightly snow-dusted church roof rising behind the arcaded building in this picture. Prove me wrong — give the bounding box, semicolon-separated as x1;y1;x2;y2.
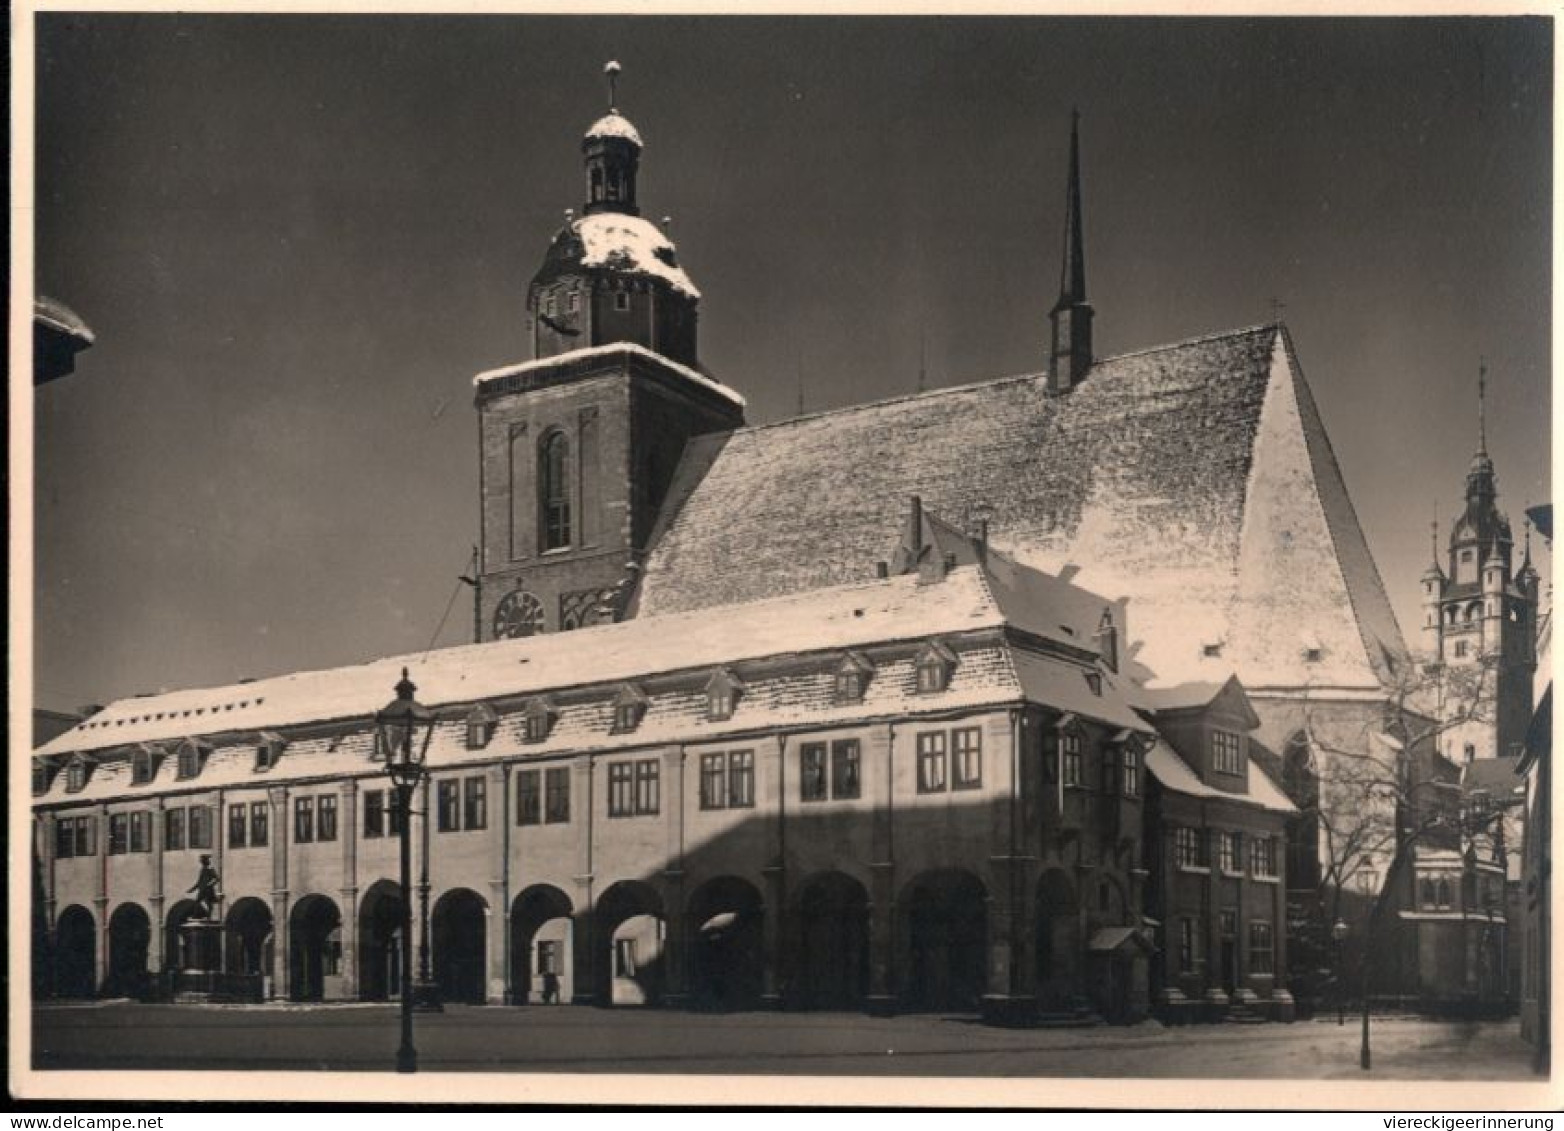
638;325;1406;691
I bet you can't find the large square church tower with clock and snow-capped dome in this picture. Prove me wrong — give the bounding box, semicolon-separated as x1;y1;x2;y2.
474;63;744;640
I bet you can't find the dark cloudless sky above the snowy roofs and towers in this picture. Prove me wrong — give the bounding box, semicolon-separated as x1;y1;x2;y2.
36;14;1553;707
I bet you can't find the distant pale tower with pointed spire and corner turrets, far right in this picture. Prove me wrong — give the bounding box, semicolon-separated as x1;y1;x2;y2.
1422;371;1537;765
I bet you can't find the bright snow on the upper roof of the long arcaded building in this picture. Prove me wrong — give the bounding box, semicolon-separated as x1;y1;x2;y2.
38;566;1134;766
